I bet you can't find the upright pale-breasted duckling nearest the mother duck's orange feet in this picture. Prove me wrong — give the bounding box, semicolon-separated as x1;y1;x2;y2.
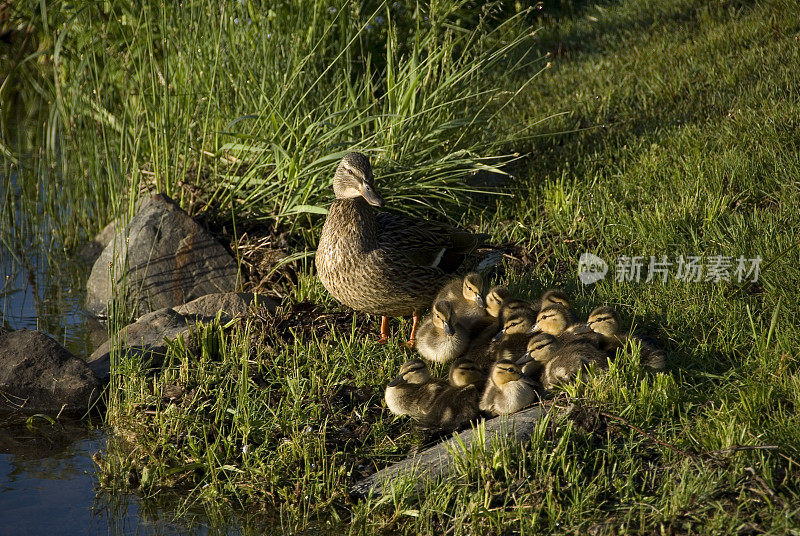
417;300;469;363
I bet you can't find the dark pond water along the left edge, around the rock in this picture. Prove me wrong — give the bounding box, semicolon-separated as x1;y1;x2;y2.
0;182;241;535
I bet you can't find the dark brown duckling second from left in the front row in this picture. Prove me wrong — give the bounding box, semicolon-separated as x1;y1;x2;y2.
420;359;486;431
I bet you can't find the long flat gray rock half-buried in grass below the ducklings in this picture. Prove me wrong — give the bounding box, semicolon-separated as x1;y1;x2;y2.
349;405;544;499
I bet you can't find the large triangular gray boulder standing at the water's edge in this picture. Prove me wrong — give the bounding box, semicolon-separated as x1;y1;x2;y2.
86;194;238;316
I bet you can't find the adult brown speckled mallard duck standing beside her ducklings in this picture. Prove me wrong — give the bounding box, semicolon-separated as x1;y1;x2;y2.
316;153;485;344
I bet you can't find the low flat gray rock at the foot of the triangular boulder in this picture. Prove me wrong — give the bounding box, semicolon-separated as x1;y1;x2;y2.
88;292;278;382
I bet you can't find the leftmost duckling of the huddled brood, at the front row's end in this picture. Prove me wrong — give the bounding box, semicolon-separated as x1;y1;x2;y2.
385;359;446;419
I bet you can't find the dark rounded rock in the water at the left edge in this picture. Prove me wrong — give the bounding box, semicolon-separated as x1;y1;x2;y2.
0;327;101;416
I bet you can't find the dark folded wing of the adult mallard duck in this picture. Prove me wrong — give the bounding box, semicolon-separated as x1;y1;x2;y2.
376;208;488;273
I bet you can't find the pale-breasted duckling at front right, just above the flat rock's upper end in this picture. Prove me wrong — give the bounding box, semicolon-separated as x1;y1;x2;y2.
480;359;539;415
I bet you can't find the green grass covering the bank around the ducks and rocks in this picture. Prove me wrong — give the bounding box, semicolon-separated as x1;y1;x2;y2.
4;0;800;534
